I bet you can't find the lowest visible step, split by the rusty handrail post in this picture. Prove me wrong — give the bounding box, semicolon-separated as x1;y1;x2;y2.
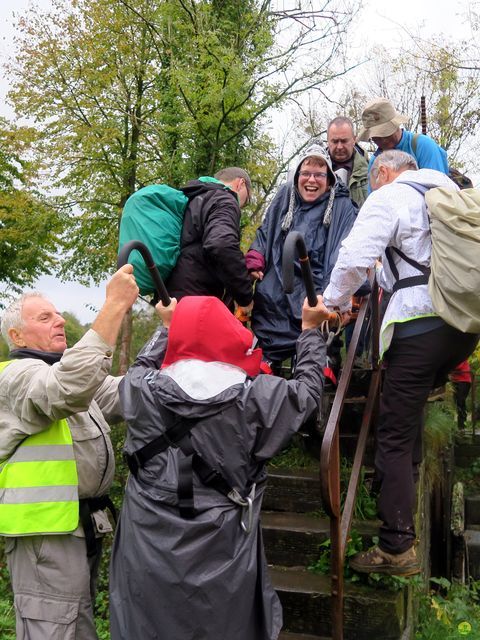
269;566;408;640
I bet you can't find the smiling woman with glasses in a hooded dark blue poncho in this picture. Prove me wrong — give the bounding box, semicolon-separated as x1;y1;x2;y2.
246;144;358;371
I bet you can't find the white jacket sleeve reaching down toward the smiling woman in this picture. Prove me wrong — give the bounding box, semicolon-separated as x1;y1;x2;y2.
323;189;398;311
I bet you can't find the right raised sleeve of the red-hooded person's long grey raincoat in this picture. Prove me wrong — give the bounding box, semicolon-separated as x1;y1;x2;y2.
247;329;326;462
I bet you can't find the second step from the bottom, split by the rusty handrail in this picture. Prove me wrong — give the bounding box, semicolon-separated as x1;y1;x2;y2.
261;511;379;566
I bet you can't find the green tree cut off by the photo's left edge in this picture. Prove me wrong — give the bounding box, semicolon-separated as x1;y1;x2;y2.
0;119;62;297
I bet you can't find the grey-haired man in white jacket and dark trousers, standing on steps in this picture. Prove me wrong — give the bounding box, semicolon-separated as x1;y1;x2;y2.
324;150;478;575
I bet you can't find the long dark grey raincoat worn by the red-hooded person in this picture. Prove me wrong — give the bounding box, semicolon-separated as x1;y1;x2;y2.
110;329;326;640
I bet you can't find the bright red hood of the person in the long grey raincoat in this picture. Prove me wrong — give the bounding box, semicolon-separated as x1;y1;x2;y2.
162;296;262;377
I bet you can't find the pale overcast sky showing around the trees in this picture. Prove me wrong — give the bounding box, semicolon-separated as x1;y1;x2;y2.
0;0;472;323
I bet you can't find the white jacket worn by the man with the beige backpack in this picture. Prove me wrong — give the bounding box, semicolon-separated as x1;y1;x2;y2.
324;169;458;353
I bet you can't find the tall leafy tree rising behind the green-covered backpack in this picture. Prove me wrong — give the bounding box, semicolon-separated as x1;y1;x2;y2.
9;0;358;368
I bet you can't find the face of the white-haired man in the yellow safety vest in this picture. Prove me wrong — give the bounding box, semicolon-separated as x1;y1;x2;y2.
11;297;67;353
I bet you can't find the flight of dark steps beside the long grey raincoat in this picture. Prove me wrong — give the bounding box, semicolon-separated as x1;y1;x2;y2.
262;469;411;640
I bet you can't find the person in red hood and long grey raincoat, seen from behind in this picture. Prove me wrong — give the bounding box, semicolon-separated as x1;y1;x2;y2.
110;296;327;640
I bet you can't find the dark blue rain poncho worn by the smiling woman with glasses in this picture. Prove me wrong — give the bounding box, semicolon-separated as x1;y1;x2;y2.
247;182;358;361
